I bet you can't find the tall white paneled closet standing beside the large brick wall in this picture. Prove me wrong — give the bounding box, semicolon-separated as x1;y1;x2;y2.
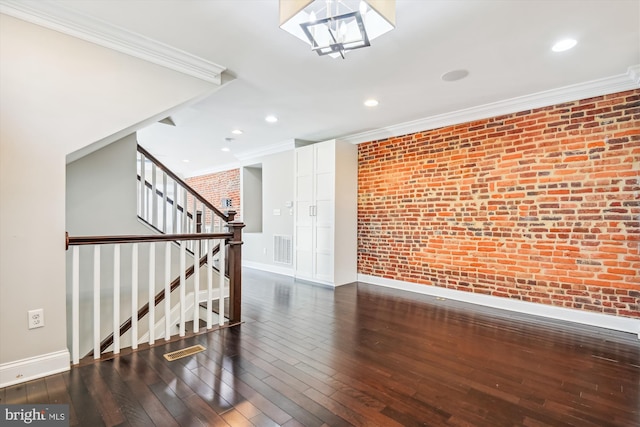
294;140;358;286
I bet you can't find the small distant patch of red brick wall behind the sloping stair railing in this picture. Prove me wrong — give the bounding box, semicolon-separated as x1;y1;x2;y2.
185;169;242;224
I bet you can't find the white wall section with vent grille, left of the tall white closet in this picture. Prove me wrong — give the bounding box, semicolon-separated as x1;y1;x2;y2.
242;150;294;274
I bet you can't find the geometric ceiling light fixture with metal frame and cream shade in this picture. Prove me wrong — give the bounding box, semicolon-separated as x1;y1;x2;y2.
280;0;396;59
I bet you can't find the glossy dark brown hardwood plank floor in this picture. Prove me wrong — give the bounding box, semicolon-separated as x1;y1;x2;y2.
0;270;640;427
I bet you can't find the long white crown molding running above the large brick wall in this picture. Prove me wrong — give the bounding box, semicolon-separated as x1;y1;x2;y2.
338;65;640;144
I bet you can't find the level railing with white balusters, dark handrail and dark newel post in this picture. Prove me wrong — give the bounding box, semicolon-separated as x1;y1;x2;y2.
66;222;244;364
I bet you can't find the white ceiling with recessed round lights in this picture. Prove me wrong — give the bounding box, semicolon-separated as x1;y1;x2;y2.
6;0;640;176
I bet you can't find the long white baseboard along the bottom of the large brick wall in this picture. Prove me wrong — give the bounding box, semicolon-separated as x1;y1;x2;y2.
358;274;640;339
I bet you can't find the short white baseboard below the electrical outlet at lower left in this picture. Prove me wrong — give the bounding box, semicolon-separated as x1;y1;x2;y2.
0;350;71;388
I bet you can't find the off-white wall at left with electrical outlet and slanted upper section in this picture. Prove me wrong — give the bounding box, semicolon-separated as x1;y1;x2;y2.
0;15;215;386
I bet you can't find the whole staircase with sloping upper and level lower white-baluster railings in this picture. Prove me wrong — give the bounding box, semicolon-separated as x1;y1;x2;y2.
66;146;244;364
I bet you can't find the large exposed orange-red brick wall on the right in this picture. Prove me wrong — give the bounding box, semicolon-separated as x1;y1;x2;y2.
358;90;640;317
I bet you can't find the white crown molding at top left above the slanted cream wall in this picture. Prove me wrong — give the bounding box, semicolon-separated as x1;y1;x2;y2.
0;0;226;85
